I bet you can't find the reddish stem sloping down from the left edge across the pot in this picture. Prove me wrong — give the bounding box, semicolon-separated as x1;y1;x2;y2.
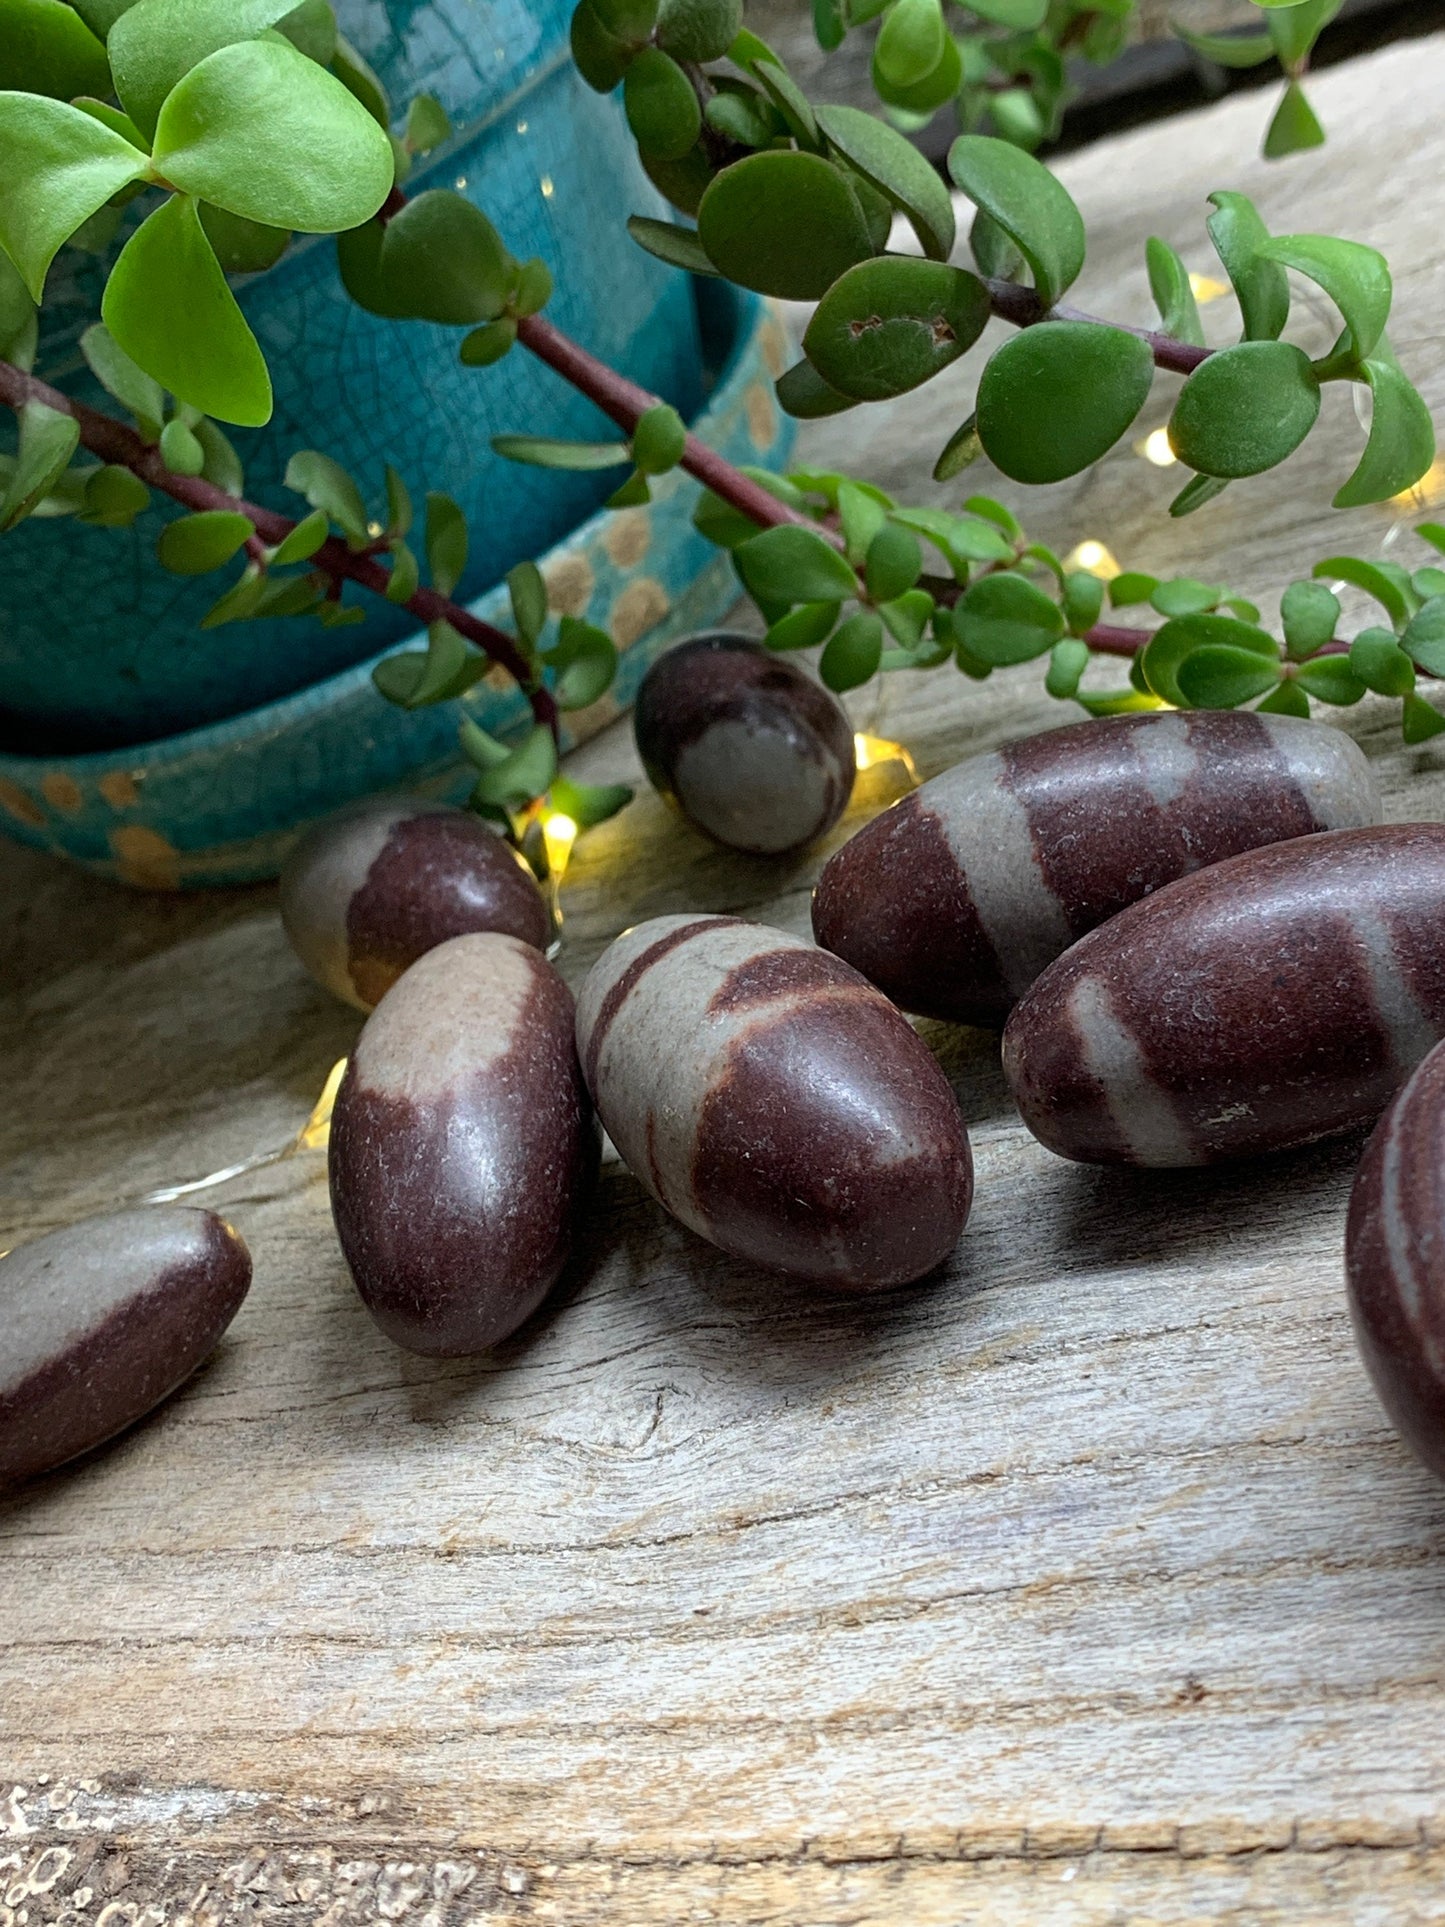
0;362;559;734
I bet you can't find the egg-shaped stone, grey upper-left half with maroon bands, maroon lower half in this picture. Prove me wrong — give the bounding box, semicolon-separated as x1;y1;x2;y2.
578;917;973;1291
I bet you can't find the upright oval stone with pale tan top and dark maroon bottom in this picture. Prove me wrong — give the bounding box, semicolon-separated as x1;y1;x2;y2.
329;935;597;1357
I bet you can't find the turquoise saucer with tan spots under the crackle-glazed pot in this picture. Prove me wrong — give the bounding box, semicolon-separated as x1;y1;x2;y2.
0;276;792;888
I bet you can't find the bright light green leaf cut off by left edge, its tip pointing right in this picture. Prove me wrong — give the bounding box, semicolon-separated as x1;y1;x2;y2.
0;92;146;303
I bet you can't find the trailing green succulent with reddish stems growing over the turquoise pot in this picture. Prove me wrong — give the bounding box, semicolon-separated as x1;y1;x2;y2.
0;0;1445;867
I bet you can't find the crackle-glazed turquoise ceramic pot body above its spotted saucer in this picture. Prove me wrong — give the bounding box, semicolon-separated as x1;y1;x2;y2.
0;0;701;753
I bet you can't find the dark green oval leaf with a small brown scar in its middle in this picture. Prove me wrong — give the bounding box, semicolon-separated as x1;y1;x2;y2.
803;254;990;401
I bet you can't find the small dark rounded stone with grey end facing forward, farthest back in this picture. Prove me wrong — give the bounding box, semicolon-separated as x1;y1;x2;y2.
632;630;855;856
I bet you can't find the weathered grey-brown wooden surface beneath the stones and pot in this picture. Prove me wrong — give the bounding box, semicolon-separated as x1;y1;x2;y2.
0;42;1445;1927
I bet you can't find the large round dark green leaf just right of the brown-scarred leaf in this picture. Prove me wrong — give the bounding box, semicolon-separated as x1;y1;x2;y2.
979;322;1163;484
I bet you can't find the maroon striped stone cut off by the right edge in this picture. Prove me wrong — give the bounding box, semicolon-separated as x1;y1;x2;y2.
1345;1044;1445;1478
